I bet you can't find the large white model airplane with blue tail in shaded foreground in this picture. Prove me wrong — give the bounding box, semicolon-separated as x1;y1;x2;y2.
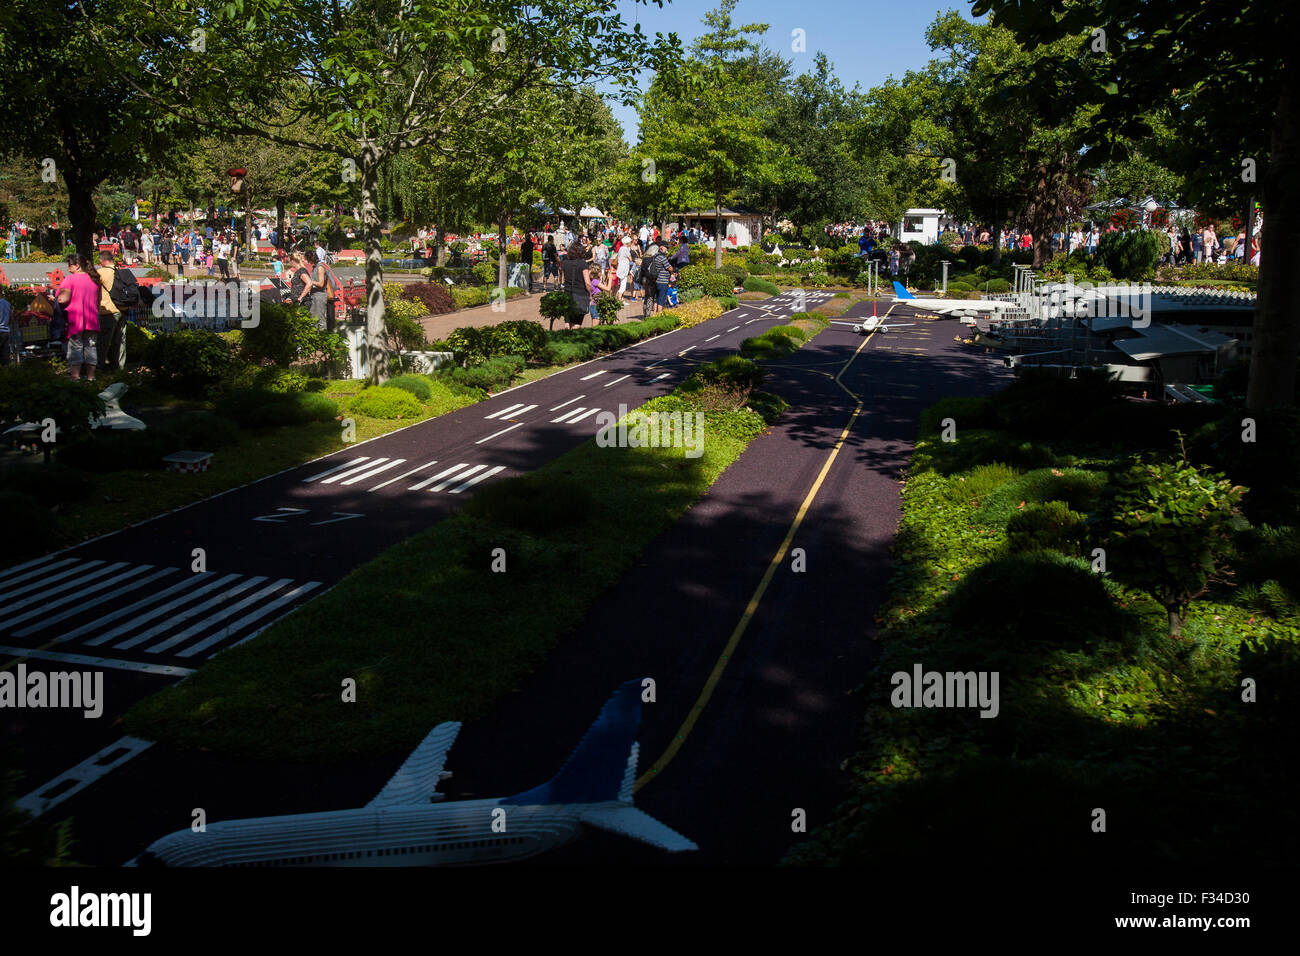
127;680;698;866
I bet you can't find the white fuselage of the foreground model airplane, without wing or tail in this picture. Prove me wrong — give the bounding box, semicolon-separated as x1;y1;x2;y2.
139;799;605;866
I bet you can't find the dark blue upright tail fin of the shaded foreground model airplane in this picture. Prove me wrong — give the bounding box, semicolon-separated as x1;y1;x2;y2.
502;679;641;806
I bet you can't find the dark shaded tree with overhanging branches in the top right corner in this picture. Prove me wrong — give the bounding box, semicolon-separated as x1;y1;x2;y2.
972;0;1300;408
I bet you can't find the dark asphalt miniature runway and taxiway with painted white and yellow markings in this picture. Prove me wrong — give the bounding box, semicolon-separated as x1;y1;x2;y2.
0;297;1001;865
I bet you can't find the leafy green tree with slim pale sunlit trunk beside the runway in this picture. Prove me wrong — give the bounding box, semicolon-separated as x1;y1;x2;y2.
83;0;677;381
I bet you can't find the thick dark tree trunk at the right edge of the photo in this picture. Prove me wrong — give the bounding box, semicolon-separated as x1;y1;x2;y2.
1245;70;1300;410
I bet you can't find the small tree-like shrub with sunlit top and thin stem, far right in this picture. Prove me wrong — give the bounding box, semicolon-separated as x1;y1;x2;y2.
1105;462;1247;635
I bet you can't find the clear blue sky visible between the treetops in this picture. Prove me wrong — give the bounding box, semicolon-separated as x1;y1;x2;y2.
611;0;970;144
